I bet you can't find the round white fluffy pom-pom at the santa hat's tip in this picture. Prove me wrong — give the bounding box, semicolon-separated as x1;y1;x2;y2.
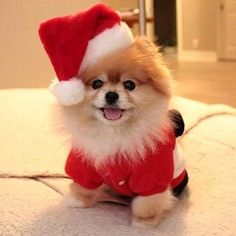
49;77;85;106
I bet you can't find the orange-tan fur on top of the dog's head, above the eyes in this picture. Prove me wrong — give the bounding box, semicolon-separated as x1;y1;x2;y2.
80;37;171;97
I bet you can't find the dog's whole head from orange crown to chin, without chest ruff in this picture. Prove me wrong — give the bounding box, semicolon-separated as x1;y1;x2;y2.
80;38;170;126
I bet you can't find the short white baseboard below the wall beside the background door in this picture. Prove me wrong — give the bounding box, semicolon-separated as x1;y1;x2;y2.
178;50;217;62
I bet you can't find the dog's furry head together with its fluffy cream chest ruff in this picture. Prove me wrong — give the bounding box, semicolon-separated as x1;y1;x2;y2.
60;38;170;159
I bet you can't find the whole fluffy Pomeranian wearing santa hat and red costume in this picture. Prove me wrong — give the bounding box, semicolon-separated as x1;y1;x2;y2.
39;3;188;226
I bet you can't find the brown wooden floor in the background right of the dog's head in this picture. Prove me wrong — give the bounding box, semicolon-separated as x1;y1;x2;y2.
165;56;236;107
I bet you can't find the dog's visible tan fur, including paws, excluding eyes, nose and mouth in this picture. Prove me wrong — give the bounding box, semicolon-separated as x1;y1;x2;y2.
62;38;176;225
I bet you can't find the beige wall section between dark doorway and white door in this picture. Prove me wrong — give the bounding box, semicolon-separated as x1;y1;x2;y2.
181;0;218;51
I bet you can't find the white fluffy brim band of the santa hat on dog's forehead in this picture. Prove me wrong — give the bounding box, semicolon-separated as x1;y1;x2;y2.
79;22;134;73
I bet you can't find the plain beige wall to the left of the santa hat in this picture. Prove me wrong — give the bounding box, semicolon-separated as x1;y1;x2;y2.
0;0;98;88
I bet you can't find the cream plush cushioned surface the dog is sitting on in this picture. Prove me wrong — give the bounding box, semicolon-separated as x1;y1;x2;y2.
0;89;236;236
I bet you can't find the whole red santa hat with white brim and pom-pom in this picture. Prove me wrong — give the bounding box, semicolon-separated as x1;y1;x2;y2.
39;4;133;106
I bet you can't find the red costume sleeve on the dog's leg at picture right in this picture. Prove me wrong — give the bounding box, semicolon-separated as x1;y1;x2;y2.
129;129;175;196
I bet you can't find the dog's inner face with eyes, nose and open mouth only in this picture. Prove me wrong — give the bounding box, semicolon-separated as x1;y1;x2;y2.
85;71;140;125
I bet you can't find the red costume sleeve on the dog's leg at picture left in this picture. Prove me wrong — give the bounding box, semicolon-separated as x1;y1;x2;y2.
65;150;103;189
